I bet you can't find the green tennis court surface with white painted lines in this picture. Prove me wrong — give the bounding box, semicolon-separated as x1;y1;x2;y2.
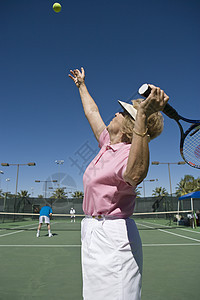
0;217;200;300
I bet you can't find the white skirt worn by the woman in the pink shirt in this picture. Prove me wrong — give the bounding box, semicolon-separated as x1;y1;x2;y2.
81;217;143;300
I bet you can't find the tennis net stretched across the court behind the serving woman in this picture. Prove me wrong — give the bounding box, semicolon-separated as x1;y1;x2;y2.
0;210;197;231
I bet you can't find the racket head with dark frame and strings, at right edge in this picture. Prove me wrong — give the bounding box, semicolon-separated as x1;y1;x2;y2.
180;123;200;169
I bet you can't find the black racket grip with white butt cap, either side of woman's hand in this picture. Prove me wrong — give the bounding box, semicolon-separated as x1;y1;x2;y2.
138;83;180;121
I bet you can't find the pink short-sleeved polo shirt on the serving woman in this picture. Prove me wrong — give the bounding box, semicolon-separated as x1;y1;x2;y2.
83;129;136;218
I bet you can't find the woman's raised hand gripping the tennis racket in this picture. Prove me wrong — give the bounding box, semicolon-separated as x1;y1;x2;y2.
140;84;169;117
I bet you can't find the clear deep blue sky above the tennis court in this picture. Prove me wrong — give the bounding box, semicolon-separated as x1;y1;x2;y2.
0;0;200;196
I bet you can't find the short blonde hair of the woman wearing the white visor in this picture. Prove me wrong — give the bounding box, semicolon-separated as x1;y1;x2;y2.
122;99;164;144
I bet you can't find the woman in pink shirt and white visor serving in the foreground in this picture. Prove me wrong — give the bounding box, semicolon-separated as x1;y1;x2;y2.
69;68;169;300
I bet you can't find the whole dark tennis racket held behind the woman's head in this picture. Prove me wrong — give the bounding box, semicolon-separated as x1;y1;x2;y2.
138;83;200;169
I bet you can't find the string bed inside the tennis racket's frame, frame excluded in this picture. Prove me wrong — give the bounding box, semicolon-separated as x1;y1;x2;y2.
183;126;200;169
